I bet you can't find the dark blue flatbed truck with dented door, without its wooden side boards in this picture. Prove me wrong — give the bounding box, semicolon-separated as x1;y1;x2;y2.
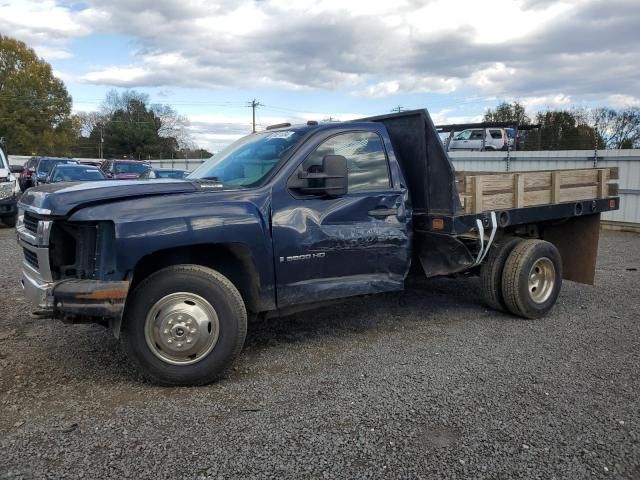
17;110;618;385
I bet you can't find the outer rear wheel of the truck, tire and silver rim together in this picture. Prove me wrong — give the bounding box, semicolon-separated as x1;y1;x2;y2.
502;240;562;318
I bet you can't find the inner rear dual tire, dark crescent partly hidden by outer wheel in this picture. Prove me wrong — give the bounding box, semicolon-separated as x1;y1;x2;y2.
480;237;522;312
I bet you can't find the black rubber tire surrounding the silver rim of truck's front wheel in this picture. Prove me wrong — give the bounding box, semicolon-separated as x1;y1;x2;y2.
121;265;247;386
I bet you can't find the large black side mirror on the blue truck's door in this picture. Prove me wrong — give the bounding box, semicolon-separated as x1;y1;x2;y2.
289;155;348;197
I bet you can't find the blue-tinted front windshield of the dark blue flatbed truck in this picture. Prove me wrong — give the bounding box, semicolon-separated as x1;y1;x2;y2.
187;130;303;187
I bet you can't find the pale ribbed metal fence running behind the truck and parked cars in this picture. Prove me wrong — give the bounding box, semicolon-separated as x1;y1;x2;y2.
9;149;640;231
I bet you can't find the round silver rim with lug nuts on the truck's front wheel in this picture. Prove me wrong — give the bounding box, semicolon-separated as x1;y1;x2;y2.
144;292;220;365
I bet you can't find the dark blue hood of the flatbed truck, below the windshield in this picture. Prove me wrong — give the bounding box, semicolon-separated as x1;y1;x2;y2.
18;179;222;216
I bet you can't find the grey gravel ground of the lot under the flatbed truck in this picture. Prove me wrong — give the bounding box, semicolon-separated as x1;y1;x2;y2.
0;228;640;479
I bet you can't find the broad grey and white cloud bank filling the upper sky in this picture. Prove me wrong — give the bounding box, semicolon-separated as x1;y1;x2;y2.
0;0;640;122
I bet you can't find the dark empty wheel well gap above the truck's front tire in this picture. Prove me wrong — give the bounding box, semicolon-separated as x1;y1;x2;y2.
130;243;260;312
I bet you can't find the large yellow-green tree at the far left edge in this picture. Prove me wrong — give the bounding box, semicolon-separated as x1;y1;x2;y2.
0;35;78;155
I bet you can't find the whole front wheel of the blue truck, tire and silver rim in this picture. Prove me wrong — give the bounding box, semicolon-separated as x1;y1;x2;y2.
121;265;247;385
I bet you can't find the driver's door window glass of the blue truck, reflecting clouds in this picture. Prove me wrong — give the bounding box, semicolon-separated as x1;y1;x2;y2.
302;132;391;192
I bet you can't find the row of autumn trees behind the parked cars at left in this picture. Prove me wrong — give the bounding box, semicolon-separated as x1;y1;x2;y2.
0;35;211;159
